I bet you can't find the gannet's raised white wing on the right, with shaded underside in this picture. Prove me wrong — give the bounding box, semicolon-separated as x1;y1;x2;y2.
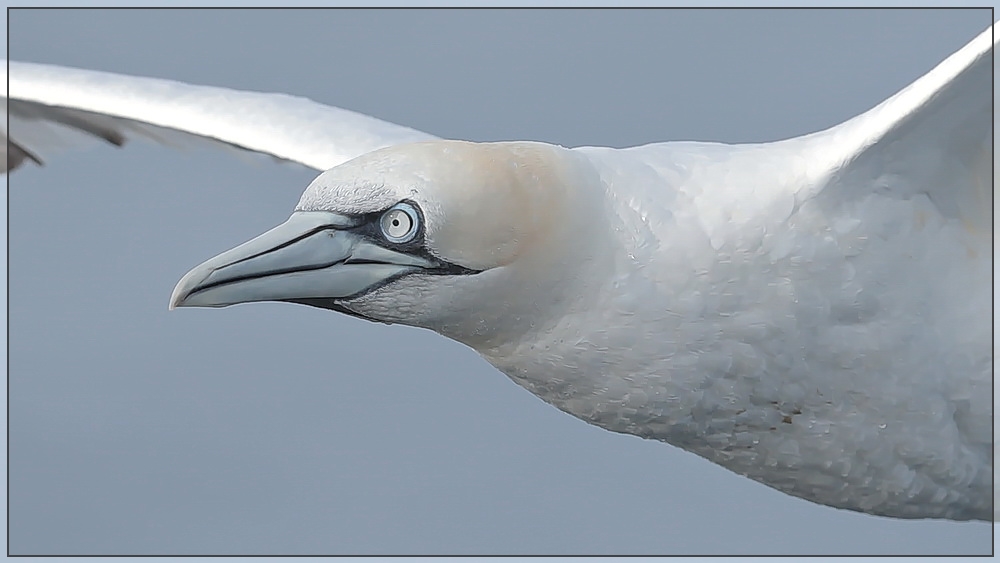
798;20;1000;233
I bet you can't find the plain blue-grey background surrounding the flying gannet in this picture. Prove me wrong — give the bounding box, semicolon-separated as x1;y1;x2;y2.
9;6;992;554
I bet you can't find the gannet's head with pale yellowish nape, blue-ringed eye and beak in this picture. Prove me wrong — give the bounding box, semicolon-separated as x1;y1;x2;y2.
170;141;604;349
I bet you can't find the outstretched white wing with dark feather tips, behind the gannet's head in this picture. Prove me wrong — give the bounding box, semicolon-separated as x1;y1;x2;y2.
3;62;435;171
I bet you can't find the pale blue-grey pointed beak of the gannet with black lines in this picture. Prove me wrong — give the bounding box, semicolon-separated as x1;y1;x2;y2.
170;211;432;309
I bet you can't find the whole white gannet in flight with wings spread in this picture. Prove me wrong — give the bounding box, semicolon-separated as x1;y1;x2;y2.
8;22;992;519
